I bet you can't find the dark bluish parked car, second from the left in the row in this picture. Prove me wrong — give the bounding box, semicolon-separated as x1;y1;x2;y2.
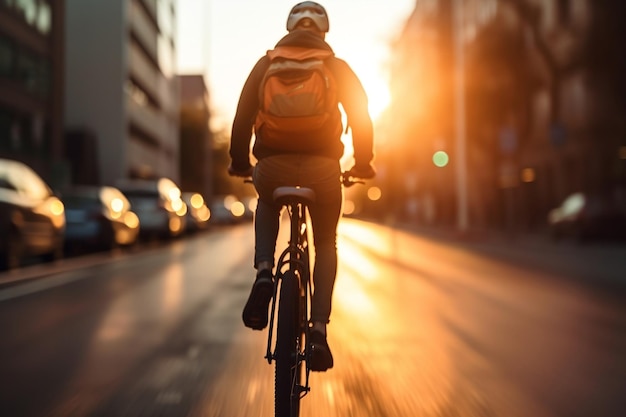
61;185;140;250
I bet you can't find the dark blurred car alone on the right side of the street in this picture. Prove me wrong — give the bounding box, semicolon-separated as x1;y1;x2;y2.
548;188;626;242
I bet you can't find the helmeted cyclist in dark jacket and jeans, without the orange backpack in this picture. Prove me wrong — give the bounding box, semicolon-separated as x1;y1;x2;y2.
228;1;375;371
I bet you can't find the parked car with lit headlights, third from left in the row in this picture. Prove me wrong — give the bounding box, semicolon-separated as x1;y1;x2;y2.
116;178;187;238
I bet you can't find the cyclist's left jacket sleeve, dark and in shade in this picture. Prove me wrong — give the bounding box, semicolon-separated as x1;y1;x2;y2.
230;57;269;171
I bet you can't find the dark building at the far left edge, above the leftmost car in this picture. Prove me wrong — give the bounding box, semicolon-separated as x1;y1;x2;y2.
0;0;68;186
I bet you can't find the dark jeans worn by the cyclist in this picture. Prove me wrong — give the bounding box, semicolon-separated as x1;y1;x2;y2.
253;155;343;323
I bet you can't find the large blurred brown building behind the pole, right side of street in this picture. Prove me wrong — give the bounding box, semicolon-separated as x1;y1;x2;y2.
390;0;626;231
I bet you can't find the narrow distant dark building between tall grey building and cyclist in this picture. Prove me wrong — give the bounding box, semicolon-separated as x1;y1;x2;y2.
179;74;213;201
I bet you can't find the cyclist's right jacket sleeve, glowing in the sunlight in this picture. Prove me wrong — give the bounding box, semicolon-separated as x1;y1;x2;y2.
331;58;374;167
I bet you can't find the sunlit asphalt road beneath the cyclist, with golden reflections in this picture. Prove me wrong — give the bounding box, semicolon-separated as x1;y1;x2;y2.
0;219;626;417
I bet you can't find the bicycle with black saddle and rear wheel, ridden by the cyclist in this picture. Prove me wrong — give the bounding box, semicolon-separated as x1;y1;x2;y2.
254;174;363;417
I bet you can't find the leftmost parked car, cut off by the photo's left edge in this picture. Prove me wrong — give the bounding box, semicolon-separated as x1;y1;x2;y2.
0;159;65;269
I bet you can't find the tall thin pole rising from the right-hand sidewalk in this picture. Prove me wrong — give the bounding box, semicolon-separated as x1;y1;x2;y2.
453;0;469;233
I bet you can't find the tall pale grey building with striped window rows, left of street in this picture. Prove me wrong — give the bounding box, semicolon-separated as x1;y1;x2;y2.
65;0;180;184
